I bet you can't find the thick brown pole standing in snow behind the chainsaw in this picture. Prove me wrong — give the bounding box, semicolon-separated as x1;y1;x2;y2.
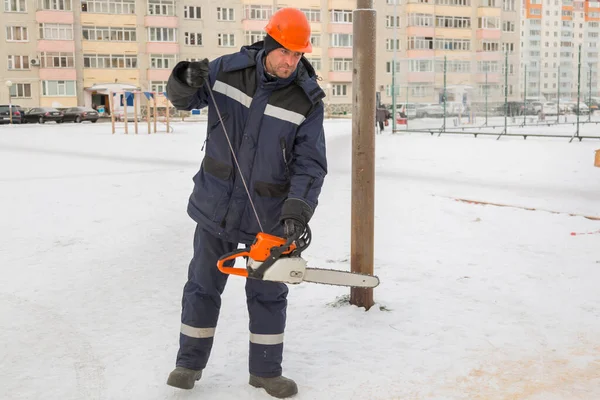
350;0;376;310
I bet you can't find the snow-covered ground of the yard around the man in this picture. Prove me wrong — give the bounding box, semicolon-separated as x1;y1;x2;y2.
0;120;600;400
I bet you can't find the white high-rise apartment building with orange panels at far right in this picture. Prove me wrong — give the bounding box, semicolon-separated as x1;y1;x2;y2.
521;0;600;99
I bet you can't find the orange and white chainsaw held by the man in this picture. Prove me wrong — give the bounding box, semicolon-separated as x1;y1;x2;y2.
217;226;379;288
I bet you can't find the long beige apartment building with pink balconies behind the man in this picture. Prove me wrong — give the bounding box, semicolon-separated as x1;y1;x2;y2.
0;0;524;111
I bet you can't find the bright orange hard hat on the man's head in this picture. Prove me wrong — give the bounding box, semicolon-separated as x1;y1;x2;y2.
265;7;312;53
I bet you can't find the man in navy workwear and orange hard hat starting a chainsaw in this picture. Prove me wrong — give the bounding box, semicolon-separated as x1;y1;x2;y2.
167;8;327;398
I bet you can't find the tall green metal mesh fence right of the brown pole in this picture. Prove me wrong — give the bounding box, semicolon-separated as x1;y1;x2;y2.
380;43;600;140
